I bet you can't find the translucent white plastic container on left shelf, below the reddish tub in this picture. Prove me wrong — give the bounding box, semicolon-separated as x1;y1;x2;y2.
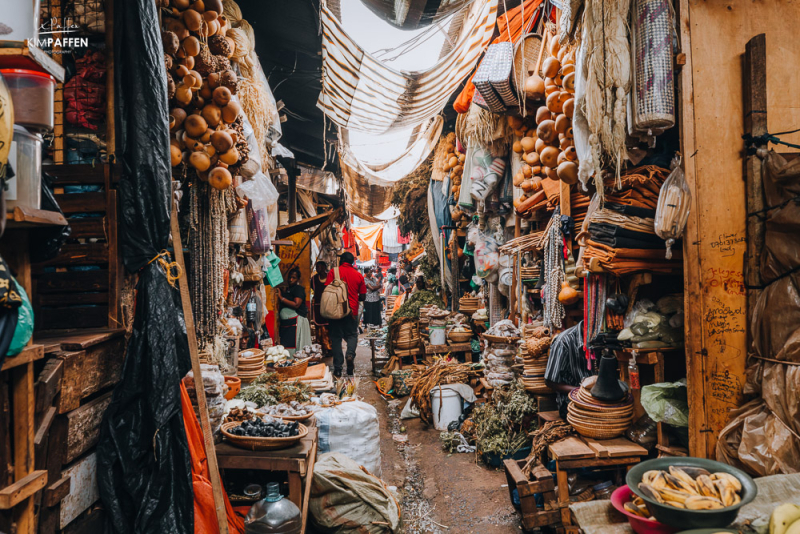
6;125;42;211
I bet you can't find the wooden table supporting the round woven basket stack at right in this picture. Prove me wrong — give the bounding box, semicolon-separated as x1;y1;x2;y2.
547;436;647;534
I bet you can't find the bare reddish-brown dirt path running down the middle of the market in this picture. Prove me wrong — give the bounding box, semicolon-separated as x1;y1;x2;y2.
356;346;521;534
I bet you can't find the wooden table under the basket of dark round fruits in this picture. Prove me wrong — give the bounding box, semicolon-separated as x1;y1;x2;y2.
216;427;319;510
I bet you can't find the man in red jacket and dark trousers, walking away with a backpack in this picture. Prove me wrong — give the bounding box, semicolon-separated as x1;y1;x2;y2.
325;252;367;378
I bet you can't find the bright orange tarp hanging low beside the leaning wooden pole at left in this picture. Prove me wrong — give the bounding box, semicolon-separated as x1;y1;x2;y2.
181;381;244;534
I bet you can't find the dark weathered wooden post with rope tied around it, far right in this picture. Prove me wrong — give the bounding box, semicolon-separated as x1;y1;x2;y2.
742;33;767;345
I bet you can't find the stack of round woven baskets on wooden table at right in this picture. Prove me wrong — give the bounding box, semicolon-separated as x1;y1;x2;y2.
567;376;633;439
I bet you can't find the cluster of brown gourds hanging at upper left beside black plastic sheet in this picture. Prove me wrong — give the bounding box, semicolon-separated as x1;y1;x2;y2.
160;0;249;190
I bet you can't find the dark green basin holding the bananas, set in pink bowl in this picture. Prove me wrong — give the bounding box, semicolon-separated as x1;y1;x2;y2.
625;457;758;529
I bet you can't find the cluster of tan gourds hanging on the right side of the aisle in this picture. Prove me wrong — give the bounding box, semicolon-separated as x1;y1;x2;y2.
508;39;578;216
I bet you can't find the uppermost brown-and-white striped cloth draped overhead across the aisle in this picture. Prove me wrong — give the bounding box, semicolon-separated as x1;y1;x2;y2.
317;0;497;134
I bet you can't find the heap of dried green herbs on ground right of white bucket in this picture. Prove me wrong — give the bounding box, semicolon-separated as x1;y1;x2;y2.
472;382;536;456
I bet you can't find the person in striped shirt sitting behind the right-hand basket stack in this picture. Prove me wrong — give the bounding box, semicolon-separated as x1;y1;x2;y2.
544;321;593;421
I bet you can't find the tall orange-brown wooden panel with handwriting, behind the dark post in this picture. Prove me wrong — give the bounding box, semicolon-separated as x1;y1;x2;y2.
681;0;800;457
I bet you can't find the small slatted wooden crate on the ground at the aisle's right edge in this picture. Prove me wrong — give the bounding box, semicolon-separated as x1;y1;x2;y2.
503;460;561;530
